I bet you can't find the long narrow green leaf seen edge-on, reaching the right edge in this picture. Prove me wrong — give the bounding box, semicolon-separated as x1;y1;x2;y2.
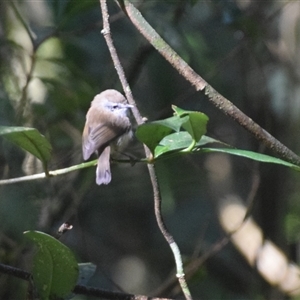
196;148;300;171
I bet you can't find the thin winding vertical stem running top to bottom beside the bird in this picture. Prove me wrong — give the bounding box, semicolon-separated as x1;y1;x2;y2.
100;0;192;300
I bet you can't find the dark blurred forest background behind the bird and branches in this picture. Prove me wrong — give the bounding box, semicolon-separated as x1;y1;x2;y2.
0;0;300;299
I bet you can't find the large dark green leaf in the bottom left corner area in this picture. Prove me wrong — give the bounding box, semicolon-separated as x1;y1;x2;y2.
24;231;78;300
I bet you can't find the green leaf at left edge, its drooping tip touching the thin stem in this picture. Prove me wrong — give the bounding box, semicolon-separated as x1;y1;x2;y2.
0;126;52;171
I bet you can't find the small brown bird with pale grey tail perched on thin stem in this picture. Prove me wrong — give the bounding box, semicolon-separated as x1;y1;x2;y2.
82;90;133;185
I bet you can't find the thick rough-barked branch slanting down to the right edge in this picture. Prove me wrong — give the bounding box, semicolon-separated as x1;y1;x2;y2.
124;0;300;165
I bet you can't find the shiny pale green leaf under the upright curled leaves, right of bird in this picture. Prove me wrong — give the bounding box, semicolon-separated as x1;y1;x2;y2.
154;131;218;158
